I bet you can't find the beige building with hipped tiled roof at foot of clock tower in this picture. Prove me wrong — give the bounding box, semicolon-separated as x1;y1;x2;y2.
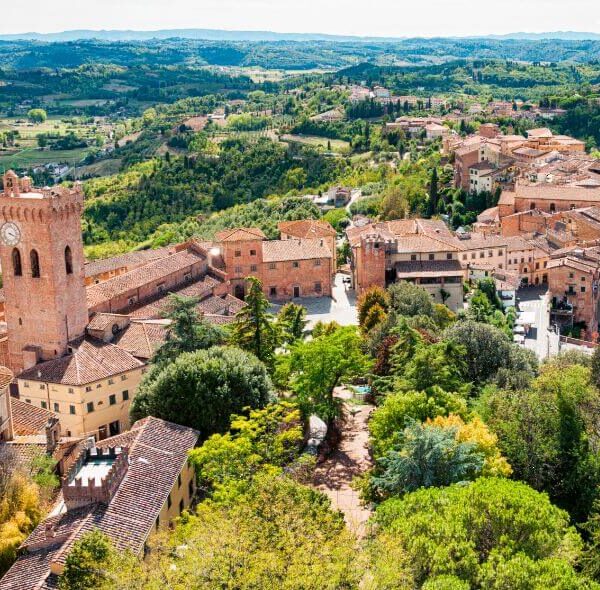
17;338;145;440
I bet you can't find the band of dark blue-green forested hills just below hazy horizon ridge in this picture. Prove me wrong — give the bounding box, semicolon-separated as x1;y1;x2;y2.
0;38;600;70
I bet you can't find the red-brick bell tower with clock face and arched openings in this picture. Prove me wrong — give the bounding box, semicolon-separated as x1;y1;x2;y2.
0;171;88;374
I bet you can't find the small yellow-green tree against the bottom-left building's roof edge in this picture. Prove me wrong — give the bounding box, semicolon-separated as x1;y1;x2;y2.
58;529;112;590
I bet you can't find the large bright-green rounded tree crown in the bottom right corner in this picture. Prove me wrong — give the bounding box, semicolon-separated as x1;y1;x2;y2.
376;478;585;590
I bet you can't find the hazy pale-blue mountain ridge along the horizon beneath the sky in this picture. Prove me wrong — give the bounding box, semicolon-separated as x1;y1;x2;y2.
0;29;600;43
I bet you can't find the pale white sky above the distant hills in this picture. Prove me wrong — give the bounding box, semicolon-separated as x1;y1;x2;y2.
0;0;600;37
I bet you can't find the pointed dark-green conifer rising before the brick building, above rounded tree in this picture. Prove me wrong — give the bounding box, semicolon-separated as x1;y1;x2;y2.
231;277;280;367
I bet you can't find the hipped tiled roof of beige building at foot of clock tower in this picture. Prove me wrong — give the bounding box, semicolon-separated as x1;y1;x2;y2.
19;338;143;385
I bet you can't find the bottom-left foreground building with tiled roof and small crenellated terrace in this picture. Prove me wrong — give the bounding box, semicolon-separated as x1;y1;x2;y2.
0;417;198;590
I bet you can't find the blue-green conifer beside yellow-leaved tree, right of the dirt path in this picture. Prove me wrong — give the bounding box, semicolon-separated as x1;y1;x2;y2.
372;422;484;496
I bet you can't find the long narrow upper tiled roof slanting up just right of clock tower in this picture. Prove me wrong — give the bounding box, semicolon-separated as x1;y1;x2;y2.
87;250;202;308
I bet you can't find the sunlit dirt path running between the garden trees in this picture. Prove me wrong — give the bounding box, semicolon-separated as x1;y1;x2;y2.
314;403;373;537
